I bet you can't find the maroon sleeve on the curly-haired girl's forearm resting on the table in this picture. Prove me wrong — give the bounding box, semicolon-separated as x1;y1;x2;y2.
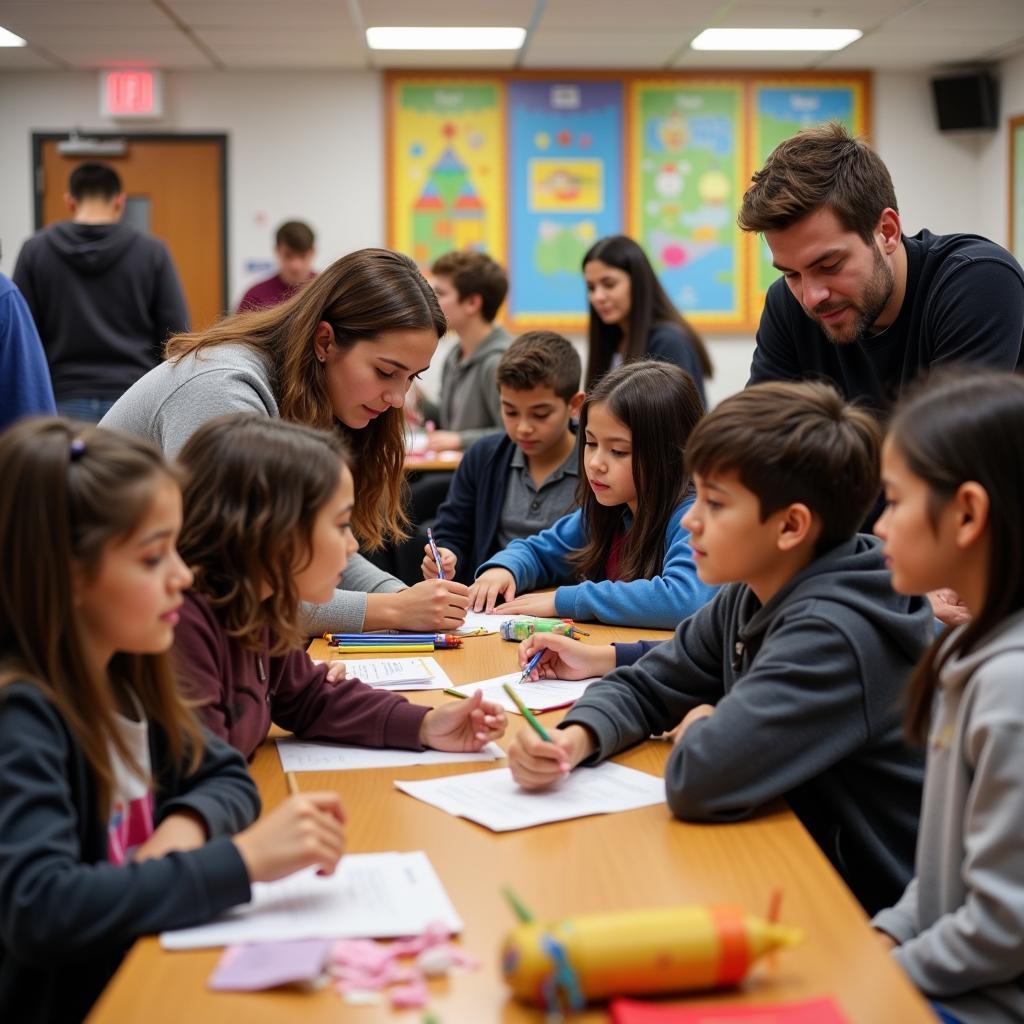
270;651;430;751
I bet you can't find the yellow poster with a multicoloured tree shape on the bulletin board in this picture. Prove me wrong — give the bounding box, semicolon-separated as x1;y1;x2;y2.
389;77;506;268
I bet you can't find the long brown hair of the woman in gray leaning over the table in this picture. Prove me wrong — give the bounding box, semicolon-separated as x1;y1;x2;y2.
167;249;447;549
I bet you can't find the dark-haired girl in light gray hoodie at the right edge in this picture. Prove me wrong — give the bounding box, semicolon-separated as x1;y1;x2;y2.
872;372;1024;1024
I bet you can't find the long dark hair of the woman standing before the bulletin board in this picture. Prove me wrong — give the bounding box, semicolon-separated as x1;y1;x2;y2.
583;234;715;389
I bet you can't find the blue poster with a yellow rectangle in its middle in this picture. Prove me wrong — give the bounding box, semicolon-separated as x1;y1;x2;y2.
508;80;623;330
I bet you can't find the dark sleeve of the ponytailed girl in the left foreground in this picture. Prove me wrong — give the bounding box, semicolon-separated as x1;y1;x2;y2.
0;683;251;967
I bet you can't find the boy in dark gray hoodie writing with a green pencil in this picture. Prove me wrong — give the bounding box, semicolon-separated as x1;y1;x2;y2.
509;383;933;911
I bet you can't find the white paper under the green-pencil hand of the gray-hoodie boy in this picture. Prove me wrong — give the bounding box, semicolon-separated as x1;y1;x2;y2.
394;761;665;831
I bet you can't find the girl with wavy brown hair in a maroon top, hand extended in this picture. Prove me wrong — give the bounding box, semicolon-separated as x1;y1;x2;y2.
175;414;505;758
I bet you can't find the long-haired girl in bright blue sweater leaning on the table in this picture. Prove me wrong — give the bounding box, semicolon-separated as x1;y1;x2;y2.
469;360;714;629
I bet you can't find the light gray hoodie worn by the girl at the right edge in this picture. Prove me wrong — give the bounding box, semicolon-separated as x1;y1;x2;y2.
871;611;1024;1024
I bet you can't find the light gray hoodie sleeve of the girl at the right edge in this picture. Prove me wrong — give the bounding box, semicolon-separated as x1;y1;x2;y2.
893;652;1024;998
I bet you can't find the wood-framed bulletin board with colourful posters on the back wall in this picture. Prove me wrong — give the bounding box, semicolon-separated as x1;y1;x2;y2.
386;72;872;333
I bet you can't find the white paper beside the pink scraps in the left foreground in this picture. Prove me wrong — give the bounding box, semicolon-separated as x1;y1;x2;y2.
160;850;463;949
